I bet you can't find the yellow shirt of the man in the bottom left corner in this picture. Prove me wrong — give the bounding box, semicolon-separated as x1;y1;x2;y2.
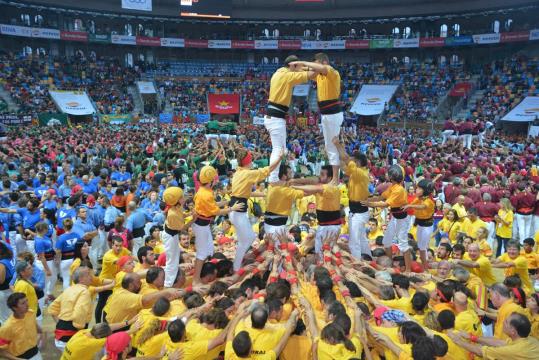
0;310;37;357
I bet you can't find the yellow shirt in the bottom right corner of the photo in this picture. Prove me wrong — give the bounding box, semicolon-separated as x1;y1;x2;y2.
481;336;539;360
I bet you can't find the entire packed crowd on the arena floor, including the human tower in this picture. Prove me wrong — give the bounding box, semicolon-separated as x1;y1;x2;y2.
0;54;539;360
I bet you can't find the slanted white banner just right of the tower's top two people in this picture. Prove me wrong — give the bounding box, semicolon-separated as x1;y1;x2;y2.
350;85;398;115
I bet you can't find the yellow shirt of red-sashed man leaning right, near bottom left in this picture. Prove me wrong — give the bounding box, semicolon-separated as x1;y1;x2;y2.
48;284;93;329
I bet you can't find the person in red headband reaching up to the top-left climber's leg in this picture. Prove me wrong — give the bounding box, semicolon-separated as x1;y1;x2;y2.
229;148;284;271
